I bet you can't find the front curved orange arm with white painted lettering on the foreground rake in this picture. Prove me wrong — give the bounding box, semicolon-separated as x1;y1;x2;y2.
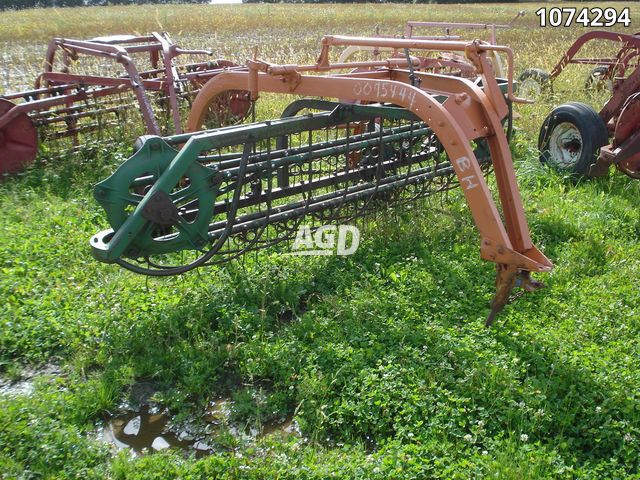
188;71;551;271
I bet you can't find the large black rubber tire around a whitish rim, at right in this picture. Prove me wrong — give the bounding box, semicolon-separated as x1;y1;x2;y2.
538;102;609;177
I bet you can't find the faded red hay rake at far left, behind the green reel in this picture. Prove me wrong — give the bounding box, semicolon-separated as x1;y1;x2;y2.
0;32;249;176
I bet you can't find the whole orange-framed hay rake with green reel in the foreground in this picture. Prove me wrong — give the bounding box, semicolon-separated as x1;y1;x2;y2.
90;36;552;324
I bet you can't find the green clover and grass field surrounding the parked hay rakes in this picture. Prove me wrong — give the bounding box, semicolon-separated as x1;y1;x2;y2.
0;3;640;479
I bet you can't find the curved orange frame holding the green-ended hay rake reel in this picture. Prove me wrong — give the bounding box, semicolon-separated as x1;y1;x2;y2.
188;36;553;324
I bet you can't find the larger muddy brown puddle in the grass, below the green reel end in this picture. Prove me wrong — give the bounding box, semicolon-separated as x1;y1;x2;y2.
99;399;299;457
